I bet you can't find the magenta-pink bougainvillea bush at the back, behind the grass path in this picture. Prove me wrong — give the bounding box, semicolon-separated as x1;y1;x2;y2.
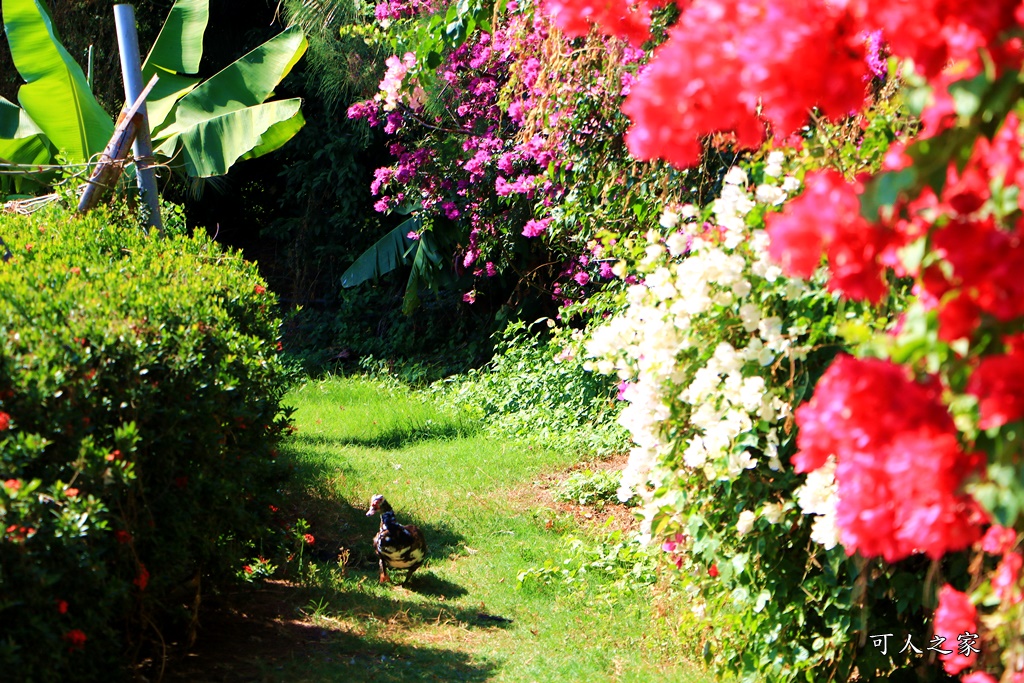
348;2;720;319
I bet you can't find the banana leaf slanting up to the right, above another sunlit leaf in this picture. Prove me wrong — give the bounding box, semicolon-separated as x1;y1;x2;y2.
159;27;307;138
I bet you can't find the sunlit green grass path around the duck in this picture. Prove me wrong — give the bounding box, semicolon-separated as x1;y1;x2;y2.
251;379;708;683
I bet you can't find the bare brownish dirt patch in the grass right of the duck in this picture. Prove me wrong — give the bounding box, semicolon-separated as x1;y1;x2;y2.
509;454;639;532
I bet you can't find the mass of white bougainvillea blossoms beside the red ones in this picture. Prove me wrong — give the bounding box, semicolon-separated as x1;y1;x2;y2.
587;157;806;535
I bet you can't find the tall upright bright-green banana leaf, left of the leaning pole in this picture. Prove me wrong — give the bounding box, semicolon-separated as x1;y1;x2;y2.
2;0;114;163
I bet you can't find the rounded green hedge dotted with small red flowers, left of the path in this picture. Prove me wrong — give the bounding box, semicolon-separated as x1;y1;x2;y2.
0;210;287;681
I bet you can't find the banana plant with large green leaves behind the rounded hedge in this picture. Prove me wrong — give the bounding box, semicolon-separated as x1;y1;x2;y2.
0;0;306;189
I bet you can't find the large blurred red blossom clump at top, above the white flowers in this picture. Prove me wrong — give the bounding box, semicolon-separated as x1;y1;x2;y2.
623;0;867;166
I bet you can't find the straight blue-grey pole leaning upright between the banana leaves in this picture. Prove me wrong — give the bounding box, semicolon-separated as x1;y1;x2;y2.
114;5;164;230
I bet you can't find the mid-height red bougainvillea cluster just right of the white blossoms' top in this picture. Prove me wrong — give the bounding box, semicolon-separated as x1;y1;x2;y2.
765;170;900;302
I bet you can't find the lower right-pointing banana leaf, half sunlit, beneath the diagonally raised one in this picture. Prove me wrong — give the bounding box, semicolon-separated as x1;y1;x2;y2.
157;98;305;178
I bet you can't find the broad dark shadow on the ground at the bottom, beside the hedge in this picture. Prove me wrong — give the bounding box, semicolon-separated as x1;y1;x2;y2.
164;582;498;683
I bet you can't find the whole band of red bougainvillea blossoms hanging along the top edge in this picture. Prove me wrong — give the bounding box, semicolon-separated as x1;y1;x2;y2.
547;0;1022;166
